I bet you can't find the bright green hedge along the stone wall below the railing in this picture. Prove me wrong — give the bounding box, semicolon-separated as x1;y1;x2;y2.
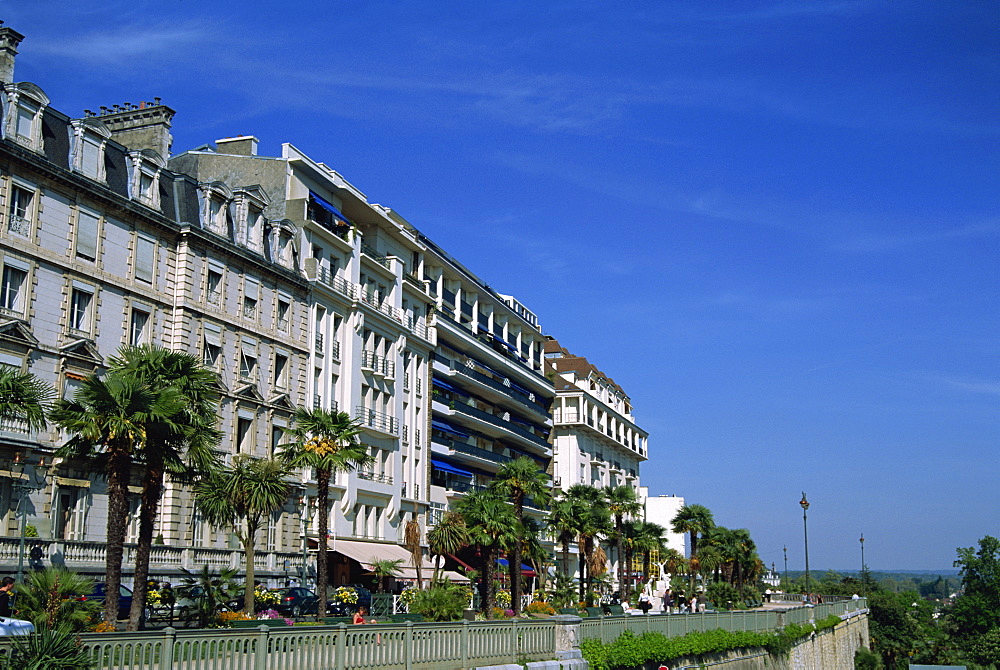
580;615;840;670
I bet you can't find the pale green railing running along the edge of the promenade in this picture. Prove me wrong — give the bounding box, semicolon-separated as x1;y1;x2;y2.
0;599;867;670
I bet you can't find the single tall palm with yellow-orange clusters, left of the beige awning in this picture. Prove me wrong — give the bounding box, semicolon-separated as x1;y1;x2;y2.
278;408;374;618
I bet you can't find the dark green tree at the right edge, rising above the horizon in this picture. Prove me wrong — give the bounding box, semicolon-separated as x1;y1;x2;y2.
948;535;1000;637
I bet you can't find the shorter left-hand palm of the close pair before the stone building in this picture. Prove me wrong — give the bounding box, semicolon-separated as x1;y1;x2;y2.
49;373;183;624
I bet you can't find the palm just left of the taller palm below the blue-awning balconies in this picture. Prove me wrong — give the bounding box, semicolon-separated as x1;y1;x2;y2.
455;490;520;617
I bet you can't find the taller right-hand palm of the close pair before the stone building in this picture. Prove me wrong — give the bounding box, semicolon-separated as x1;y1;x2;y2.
109;344;220;630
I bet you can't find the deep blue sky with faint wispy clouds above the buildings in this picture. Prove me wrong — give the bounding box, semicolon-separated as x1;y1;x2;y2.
9;0;1000;569
